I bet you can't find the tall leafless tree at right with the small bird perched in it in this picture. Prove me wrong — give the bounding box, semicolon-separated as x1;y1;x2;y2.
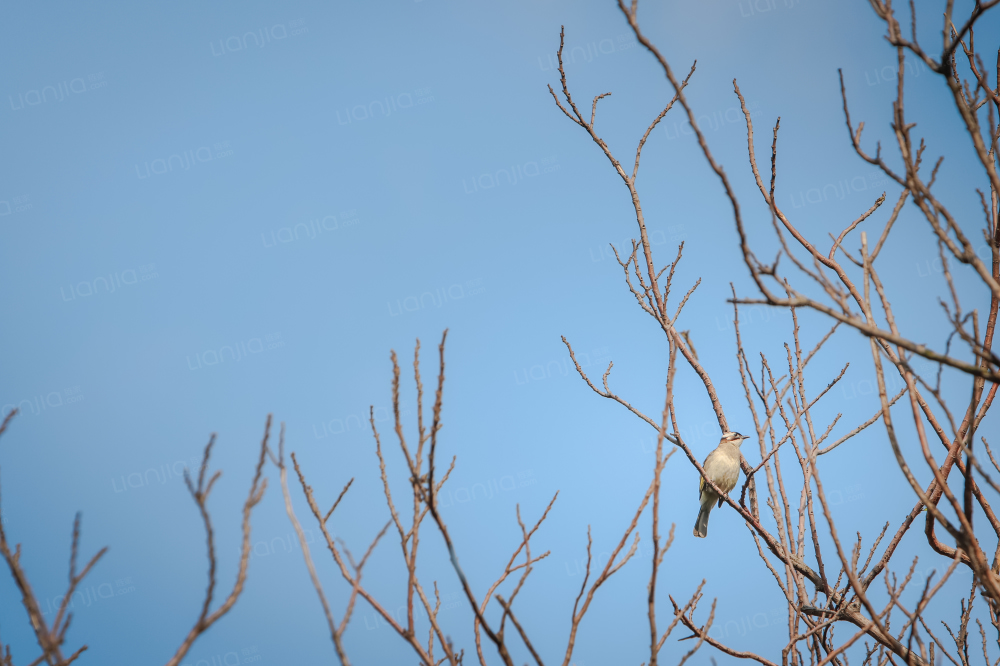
549;0;1000;665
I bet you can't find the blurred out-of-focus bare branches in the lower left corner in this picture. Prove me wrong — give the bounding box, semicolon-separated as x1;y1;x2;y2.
0;409;271;666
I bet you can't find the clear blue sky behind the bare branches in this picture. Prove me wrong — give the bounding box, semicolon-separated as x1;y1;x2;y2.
0;0;997;666
